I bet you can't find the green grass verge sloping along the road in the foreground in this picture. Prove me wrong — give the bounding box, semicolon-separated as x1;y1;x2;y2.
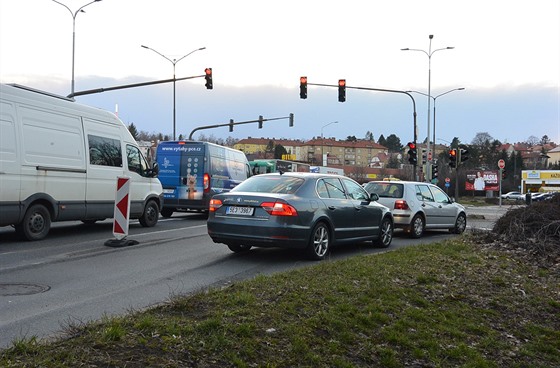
0;237;560;367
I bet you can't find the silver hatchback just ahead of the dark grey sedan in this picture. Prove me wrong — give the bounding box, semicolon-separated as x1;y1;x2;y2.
364;181;467;238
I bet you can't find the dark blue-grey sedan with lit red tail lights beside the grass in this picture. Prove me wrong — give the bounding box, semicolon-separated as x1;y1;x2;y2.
207;172;393;260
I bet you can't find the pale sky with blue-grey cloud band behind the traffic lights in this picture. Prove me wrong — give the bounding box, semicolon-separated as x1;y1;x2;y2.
0;0;560;144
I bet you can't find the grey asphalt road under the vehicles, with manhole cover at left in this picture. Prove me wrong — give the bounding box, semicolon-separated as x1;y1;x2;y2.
0;206;498;349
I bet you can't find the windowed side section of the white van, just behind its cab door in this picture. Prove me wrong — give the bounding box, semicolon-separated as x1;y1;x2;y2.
84;118;124;219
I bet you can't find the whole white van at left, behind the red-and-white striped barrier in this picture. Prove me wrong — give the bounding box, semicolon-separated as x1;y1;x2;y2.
0;84;163;240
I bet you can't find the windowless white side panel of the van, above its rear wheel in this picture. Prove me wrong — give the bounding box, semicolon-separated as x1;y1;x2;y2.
17;103;86;221
